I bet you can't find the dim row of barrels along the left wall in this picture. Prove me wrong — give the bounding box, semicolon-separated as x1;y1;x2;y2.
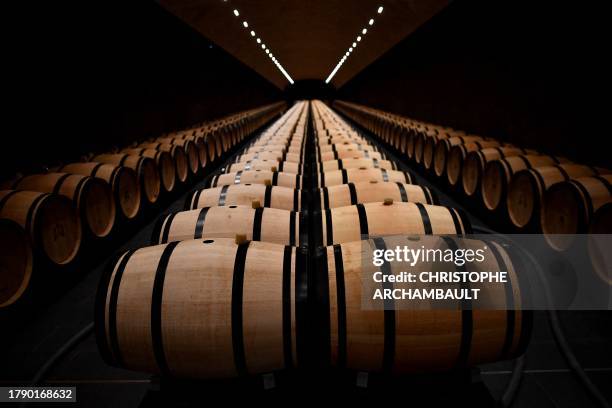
0;103;285;308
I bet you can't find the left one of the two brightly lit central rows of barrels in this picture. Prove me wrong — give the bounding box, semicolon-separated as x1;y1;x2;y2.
96;102;309;378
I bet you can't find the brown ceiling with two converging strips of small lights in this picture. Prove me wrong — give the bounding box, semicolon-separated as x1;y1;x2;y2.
160;0;450;89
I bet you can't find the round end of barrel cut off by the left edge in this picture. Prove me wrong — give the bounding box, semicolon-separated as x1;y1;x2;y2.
0;222;33;309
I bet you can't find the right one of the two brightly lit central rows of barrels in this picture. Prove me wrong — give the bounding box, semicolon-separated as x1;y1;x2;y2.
310;101;529;373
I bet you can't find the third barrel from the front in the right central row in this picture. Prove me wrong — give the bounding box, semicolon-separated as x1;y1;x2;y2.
317;182;438;209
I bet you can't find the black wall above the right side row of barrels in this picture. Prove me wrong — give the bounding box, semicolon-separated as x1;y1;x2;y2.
338;0;612;166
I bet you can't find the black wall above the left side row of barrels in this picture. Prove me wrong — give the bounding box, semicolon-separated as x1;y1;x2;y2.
0;1;282;175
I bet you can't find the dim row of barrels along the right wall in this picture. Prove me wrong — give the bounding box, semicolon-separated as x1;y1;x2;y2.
335;101;612;237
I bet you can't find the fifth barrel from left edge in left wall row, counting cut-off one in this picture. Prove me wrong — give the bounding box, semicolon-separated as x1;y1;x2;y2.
92;154;161;204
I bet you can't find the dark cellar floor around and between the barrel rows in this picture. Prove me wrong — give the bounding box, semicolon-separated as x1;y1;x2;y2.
0;116;612;407
